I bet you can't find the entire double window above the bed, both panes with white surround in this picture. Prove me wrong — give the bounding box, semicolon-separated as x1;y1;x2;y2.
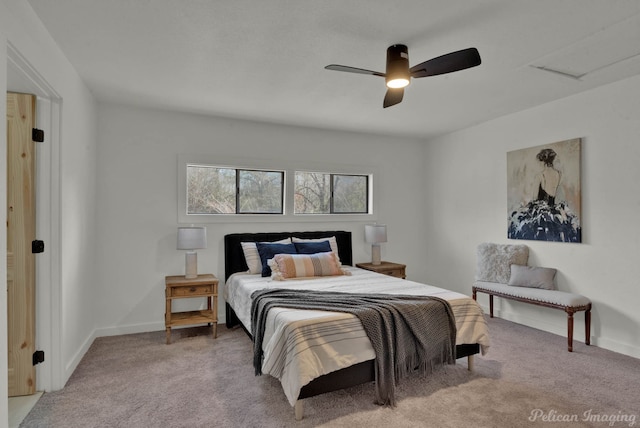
177;154;378;224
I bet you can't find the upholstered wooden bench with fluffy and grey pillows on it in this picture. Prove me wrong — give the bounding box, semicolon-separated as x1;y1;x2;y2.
473;243;591;352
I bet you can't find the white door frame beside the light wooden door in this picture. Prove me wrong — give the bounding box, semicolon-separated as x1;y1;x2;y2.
5;42;65;391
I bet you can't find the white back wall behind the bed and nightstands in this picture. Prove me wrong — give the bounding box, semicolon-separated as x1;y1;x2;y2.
95;104;425;335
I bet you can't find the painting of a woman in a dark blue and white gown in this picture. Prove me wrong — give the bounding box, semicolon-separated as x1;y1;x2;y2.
507;138;582;242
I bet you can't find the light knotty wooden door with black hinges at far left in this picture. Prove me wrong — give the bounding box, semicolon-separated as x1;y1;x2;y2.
7;93;36;397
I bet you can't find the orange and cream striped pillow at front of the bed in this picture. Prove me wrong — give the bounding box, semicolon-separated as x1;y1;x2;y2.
268;251;349;281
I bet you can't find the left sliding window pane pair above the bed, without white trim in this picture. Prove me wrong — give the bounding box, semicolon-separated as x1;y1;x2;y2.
187;164;284;214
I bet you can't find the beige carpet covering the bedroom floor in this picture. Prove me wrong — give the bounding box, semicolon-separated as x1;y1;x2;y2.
21;319;640;428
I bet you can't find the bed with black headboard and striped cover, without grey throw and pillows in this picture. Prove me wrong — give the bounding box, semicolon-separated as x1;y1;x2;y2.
223;231;489;419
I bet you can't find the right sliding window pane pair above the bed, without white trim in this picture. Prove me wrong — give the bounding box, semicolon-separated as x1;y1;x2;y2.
294;171;369;214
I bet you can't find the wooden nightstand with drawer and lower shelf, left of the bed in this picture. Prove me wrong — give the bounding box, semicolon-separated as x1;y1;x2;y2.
164;274;218;345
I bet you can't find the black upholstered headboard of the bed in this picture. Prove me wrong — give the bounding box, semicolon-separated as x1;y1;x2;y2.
224;231;353;280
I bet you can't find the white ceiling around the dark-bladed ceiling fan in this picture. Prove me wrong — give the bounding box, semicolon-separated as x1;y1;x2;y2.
23;0;640;138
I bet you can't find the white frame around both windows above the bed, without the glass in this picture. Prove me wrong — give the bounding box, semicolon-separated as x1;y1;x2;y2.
176;154;381;224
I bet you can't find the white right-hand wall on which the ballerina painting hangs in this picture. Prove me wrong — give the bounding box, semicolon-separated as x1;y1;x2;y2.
424;76;640;357
